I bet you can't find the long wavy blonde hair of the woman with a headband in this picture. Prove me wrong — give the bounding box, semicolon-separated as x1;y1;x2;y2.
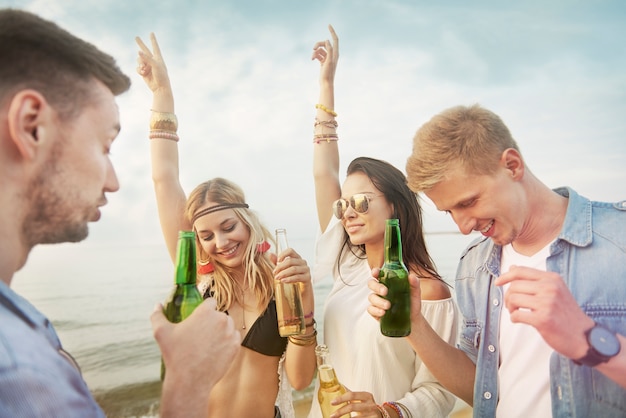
185;177;274;310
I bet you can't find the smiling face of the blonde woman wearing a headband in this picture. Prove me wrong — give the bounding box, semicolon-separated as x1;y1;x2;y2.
194;202;250;269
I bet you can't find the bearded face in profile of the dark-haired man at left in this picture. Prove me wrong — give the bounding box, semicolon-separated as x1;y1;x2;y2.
24;81;120;245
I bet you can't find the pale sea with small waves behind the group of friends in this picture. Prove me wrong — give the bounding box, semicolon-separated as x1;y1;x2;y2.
12;233;473;418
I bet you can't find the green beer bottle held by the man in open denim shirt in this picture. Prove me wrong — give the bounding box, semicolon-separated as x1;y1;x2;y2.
378;219;411;337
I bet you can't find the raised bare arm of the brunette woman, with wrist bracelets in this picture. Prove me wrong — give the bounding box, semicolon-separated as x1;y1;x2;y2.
312;25;341;232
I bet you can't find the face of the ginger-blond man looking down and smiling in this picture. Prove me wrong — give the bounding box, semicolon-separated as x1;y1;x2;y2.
425;159;526;245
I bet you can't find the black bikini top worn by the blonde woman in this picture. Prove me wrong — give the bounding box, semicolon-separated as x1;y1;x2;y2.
204;287;288;357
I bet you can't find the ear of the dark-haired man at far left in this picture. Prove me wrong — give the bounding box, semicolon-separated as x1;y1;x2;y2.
7;89;50;159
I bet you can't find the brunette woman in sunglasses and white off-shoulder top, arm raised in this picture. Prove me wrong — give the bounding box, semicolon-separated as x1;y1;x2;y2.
309;26;457;418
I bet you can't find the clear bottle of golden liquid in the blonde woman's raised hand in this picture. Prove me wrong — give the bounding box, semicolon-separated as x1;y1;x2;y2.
274;229;306;337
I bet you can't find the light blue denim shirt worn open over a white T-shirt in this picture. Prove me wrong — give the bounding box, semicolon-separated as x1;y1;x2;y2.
455;188;626;418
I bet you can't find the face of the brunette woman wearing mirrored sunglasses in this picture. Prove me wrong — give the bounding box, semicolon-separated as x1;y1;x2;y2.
341;172;393;245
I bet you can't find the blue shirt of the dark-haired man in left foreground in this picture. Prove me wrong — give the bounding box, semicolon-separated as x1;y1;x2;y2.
0;281;104;418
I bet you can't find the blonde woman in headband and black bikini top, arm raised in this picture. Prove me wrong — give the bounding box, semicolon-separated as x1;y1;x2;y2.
137;34;317;418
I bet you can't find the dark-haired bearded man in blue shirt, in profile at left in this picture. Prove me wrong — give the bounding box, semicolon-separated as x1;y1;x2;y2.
0;9;239;417
